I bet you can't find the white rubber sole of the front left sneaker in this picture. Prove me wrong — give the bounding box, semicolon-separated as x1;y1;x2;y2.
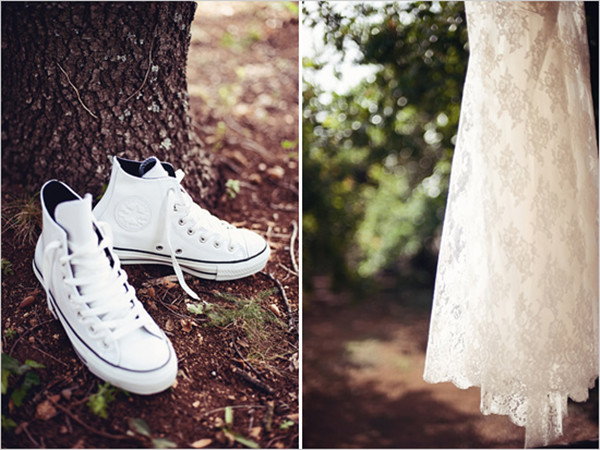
33;261;177;395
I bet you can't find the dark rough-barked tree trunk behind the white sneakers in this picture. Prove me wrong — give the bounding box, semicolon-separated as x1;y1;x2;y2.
2;2;216;198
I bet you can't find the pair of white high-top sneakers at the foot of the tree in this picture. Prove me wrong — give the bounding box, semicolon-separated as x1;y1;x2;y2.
33;157;270;395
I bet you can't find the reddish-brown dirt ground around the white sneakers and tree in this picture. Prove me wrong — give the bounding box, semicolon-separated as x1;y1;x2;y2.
2;2;299;448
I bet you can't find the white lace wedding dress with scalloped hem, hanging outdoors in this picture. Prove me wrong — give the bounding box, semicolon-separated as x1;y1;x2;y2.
424;2;598;447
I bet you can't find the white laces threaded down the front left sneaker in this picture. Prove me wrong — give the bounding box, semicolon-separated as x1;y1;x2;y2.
43;224;145;347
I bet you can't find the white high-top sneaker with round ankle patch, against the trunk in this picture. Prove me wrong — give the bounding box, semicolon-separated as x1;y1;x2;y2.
94;157;270;298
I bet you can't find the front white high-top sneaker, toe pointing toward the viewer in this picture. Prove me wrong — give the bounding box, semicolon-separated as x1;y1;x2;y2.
33;180;177;395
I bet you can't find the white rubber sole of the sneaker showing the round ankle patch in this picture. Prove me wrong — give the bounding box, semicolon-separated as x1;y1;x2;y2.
113;245;271;281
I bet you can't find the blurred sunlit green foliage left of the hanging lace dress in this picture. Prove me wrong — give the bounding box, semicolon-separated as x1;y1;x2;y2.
302;2;467;285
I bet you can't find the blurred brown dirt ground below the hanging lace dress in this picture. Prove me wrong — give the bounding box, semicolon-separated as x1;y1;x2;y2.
302;279;598;448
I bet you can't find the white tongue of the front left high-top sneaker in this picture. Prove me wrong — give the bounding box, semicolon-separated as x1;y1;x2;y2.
54;194;98;250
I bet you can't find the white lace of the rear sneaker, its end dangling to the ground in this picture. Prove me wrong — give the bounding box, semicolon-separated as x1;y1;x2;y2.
165;170;236;300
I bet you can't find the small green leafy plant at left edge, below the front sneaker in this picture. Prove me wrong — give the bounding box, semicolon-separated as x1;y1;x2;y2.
1;353;45;407
